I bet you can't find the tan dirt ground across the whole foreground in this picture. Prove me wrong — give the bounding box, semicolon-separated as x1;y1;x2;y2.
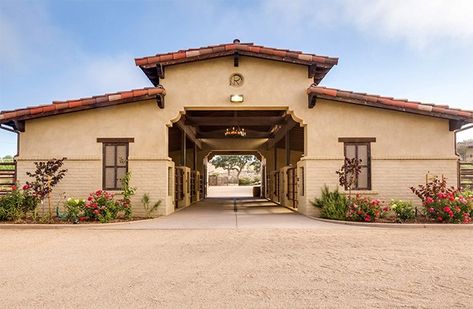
0;225;473;308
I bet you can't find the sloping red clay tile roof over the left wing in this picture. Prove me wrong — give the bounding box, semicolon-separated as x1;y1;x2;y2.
0;87;165;123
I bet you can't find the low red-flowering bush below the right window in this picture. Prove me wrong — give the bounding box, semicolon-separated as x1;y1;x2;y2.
347;194;389;222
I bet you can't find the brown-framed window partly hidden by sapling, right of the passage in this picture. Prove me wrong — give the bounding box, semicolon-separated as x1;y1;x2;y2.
338;138;376;190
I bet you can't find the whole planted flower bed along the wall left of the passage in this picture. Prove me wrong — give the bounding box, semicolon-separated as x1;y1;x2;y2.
0;164;160;223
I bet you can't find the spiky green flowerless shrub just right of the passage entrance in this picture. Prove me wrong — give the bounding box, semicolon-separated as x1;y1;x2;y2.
312;186;348;220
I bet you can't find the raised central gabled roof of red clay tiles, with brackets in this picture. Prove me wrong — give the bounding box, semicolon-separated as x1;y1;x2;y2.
135;40;338;85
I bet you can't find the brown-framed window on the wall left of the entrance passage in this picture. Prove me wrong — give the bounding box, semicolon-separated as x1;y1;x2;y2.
97;138;133;190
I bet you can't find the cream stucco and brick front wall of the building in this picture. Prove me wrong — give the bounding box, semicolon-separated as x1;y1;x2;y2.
18;57;457;214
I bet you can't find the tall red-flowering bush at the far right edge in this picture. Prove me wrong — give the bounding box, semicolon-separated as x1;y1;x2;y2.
411;177;473;223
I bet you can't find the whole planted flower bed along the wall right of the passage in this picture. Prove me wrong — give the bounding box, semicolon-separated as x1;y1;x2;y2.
312;178;473;224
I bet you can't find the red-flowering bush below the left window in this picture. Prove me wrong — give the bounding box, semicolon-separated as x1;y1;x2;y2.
79;190;120;222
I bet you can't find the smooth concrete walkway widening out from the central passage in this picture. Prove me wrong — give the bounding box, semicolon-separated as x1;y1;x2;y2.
99;198;339;229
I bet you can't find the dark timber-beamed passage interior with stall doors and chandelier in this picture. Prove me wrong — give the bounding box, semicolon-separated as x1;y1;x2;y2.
168;108;306;208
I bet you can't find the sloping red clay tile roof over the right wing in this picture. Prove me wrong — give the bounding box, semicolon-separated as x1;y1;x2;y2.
307;85;473;122
